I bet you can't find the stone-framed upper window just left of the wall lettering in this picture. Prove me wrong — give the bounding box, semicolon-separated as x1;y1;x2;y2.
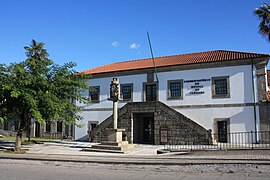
168;80;183;99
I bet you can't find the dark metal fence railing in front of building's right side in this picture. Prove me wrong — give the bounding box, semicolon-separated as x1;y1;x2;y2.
164;131;270;150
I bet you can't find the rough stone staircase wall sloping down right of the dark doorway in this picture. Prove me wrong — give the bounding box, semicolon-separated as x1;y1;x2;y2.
155;103;212;144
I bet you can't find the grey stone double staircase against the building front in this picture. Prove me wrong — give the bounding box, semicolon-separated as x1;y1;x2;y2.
89;101;212;144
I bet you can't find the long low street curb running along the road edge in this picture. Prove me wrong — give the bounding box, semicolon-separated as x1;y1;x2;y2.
0;154;270;165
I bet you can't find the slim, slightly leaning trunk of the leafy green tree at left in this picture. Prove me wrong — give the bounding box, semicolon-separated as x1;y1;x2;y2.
14;113;28;153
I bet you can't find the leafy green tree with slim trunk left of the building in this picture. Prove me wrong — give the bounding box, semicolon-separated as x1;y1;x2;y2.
0;40;90;152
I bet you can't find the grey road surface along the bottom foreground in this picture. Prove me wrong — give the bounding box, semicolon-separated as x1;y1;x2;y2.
0;159;270;180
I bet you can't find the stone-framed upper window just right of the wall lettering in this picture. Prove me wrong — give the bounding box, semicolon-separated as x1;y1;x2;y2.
212;77;230;98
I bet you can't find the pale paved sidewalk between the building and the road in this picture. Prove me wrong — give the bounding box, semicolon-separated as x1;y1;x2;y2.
0;141;270;165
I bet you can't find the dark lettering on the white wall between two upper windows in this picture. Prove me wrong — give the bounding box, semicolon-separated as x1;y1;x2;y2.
184;79;211;95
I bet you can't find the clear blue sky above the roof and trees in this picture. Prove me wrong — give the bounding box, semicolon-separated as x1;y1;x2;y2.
0;0;270;71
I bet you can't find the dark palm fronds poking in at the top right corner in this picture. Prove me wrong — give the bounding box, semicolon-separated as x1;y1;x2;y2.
254;3;270;42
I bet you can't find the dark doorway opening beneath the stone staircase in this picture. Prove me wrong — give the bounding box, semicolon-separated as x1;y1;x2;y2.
133;113;155;144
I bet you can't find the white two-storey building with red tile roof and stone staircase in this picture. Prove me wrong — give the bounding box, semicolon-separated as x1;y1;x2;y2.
75;50;270;144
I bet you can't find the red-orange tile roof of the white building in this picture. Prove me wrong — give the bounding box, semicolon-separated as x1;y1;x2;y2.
82;50;270;74
